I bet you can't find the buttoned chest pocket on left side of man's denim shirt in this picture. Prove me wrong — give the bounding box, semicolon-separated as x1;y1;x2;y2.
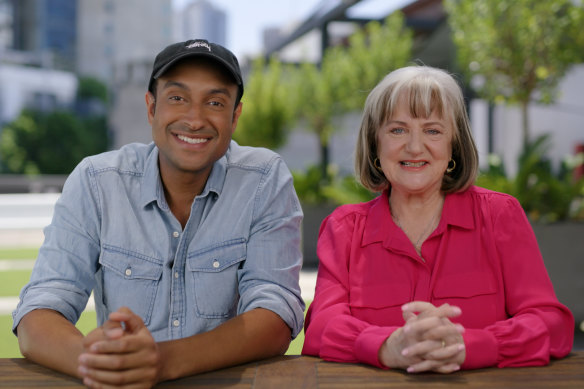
99;248;162;325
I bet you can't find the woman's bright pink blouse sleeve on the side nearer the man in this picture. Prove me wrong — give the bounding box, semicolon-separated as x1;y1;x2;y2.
302;213;398;368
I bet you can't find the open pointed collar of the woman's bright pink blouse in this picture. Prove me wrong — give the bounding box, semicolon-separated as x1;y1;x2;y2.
361;186;475;247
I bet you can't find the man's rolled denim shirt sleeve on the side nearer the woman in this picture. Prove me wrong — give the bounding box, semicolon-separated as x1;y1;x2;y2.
238;157;304;337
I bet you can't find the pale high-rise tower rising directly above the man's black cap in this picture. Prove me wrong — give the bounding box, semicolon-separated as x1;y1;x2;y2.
177;0;227;46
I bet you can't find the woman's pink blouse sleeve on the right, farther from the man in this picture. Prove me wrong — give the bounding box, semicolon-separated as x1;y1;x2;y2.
462;197;574;369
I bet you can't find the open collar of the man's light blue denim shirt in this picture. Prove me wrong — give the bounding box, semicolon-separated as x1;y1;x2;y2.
140;143;229;209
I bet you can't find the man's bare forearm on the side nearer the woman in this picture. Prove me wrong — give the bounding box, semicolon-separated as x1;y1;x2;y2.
159;308;291;381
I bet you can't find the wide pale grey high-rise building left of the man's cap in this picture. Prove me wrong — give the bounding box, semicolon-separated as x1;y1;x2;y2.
77;0;173;148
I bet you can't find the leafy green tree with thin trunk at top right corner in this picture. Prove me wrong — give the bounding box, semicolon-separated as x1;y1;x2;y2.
444;0;584;148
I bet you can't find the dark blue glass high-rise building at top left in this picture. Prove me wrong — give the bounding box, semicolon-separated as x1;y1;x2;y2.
11;0;77;70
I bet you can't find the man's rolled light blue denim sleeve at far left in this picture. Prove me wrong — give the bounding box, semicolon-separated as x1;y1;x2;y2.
12;160;99;333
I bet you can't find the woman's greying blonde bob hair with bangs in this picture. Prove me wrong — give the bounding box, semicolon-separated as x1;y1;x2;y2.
355;66;479;193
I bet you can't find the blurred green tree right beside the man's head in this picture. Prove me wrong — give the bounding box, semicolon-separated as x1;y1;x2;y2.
233;58;295;149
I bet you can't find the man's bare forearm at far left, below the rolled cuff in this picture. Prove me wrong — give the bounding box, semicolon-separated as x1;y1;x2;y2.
17;309;83;377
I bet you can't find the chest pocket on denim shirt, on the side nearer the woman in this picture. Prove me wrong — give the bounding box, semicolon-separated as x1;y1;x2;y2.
187;239;247;318
